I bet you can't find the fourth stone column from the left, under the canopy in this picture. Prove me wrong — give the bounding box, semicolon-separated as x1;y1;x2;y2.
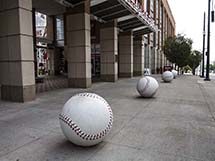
119;32;133;77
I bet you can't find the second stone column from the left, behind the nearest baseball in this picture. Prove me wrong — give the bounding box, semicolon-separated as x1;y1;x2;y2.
65;0;92;88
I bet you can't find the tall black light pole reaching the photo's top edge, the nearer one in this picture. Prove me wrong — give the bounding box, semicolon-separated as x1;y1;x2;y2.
204;0;211;81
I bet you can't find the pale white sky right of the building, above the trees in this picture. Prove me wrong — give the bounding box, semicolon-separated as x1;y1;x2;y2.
168;0;215;62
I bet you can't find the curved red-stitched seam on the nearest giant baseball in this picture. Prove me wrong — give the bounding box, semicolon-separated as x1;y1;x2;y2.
59;93;113;140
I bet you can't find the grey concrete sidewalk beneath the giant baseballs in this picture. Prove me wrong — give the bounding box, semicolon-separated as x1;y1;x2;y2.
0;76;215;161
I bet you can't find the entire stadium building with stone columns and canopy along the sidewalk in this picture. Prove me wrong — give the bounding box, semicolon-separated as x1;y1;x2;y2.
0;0;175;102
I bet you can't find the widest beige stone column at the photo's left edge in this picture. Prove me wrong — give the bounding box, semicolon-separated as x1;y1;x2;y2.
0;0;36;102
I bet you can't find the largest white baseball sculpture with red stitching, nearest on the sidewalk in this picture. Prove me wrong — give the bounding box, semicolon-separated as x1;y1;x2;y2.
59;93;113;146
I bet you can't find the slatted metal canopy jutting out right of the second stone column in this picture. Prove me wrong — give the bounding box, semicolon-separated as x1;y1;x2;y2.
91;0;156;33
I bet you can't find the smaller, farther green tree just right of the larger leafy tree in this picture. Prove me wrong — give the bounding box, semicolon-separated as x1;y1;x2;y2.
188;50;202;75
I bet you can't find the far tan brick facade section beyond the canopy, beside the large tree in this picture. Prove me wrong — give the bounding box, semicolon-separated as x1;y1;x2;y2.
144;0;175;73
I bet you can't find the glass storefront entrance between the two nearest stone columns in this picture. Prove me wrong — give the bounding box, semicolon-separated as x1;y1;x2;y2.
35;12;67;78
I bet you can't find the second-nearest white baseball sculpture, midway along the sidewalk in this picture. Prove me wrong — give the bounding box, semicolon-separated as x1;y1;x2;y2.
137;76;159;97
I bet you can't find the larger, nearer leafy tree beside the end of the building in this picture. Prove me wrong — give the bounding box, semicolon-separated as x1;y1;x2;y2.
163;34;193;67
